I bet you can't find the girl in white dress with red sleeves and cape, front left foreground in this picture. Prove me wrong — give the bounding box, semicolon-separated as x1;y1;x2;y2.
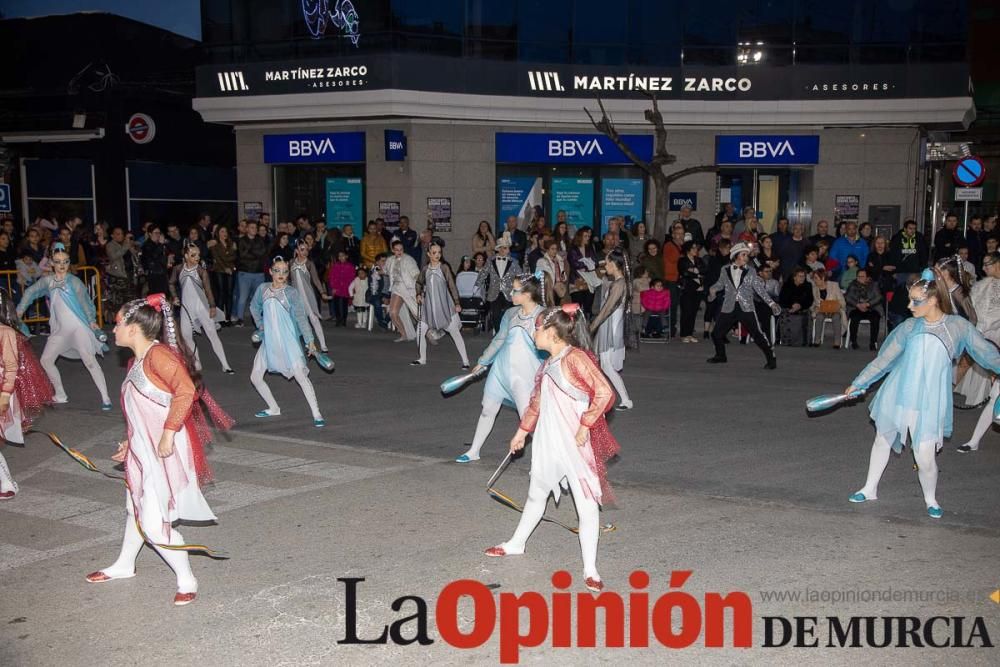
86;294;232;606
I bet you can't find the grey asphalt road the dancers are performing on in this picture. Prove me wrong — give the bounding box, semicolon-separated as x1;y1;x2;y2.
0;328;1000;665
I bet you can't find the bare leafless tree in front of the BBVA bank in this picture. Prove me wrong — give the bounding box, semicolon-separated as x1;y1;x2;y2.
583;93;716;233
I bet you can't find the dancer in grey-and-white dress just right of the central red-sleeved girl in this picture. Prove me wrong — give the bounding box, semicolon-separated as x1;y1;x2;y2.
590;252;632;410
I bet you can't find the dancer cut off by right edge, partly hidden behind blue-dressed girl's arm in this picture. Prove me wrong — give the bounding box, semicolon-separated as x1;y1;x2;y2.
955;252;1000;454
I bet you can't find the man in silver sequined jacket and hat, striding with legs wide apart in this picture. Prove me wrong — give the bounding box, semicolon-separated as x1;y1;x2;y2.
708;241;781;370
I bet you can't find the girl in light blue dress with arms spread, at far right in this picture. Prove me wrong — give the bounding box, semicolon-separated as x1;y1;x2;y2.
844;269;1000;519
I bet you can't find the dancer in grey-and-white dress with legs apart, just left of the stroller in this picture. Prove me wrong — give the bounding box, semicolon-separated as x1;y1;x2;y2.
410;243;469;370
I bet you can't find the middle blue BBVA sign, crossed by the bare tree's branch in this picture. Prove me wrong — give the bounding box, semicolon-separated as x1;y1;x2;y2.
496;132;653;164
